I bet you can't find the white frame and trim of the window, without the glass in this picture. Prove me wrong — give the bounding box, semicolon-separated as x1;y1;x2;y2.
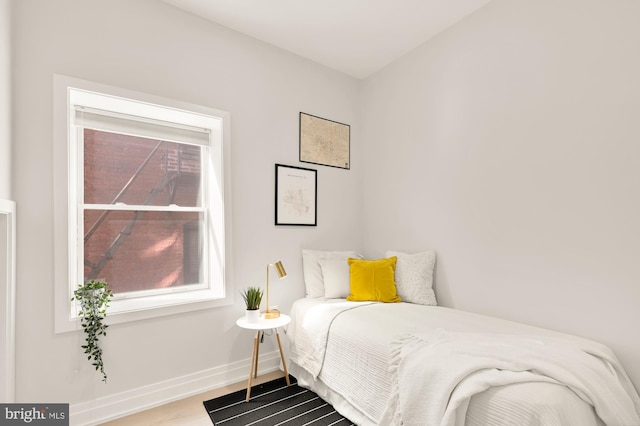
53;75;233;333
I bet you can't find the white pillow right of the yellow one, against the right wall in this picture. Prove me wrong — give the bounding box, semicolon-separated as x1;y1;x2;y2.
385;250;438;306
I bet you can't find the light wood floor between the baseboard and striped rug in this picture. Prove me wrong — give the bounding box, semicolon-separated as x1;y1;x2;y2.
103;370;284;426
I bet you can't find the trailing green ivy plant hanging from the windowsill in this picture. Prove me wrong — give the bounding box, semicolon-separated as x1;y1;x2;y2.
71;280;113;383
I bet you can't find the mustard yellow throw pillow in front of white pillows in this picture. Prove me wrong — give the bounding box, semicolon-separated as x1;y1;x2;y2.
347;256;400;302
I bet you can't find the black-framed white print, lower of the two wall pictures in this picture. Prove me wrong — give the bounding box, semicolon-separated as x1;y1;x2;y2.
275;164;318;226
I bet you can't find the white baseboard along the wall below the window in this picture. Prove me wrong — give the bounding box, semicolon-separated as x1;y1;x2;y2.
69;351;280;426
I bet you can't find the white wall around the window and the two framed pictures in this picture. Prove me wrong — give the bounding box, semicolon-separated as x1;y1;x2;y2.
13;0;362;416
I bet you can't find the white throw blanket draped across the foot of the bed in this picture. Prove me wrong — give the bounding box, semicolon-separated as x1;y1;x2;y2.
382;330;640;426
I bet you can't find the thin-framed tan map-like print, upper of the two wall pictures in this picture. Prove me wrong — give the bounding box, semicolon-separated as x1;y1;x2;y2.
300;112;351;169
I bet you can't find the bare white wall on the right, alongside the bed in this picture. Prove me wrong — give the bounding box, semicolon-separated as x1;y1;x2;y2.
362;0;640;387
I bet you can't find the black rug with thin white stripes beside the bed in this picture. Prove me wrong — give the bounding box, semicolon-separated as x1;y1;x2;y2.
204;376;353;426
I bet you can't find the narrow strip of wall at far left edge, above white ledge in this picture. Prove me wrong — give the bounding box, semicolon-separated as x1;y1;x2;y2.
0;0;11;200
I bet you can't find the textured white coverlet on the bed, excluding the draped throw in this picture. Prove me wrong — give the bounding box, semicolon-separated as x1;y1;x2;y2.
287;298;640;426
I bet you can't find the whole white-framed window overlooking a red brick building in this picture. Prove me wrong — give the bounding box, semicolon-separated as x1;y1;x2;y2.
54;76;231;331
